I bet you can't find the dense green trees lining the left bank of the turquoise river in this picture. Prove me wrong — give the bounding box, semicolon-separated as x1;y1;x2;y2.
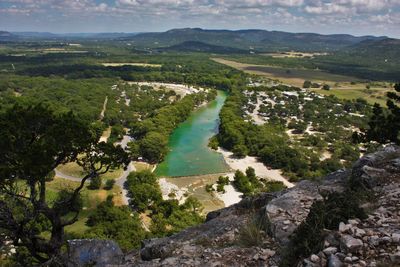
129;90;217;163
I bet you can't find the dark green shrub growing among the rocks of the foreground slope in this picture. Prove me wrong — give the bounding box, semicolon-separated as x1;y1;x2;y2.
280;191;366;267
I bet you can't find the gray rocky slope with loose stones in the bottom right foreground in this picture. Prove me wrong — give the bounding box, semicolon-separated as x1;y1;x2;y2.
70;146;400;266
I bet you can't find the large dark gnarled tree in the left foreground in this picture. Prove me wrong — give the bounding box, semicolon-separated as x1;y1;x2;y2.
0;104;129;265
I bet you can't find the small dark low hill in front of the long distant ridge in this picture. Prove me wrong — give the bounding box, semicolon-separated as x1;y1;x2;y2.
159;41;249;54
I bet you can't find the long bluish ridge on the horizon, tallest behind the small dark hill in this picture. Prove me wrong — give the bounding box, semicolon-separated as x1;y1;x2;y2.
123;28;387;51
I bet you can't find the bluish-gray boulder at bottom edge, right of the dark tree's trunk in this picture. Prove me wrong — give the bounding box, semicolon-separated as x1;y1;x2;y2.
67;239;124;267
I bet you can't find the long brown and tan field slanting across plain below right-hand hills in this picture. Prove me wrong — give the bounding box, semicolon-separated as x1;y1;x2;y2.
212;58;359;87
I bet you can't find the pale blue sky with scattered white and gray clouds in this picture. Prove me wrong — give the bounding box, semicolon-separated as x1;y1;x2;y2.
0;0;400;38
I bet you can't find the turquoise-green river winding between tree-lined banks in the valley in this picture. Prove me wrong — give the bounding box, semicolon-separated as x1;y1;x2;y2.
155;91;228;177
